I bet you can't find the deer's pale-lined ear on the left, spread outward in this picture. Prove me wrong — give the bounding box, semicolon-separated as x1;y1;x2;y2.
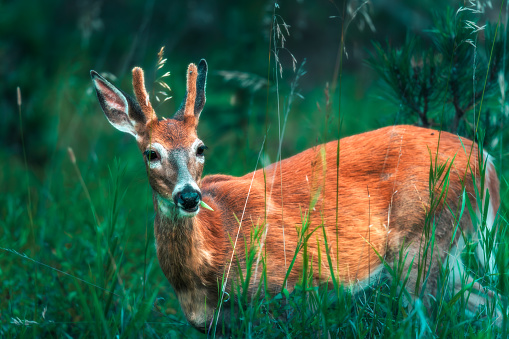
90;71;146;137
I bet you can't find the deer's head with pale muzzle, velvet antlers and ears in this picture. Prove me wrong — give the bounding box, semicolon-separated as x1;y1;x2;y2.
91;60;207;217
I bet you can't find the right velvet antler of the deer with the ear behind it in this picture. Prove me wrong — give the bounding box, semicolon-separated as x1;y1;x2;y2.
173;59;207;124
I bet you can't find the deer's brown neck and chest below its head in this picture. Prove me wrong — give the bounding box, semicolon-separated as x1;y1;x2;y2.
154;193;224;328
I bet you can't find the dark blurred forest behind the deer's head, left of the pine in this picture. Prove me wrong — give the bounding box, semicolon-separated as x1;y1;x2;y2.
0;0;499;174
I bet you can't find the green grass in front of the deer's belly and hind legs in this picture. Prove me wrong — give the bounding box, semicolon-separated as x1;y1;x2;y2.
206;142;509;338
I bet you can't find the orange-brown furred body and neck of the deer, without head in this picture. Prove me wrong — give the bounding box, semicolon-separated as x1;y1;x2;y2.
150;126;496;328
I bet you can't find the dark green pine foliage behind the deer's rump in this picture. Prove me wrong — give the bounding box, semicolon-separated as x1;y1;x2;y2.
368;8;509;144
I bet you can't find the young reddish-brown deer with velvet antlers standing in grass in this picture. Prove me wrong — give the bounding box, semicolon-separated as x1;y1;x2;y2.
91;59;500;331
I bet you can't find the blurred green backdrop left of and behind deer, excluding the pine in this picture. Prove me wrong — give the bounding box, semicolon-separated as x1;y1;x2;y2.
0;0;508;335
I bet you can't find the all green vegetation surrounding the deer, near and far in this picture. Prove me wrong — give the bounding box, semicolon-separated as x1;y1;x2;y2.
0;0;509;337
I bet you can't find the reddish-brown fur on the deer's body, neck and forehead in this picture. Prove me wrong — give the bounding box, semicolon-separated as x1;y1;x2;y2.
89;60;499;330
